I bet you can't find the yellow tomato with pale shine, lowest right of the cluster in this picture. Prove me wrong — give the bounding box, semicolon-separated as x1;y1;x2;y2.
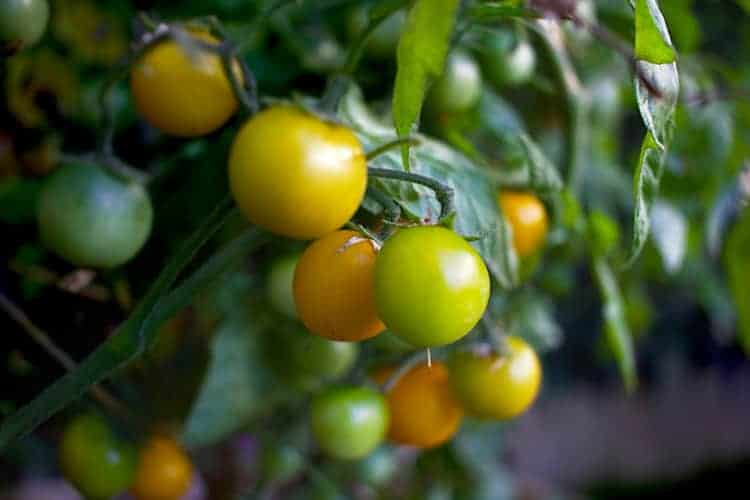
448;336;542;420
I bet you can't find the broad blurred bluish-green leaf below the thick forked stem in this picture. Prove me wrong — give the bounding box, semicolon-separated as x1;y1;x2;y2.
183;315;273;446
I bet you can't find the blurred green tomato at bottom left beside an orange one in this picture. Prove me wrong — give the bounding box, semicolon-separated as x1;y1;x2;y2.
59;415;137;498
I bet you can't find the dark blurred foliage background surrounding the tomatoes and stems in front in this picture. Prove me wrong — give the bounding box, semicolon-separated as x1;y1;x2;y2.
0;0;750;500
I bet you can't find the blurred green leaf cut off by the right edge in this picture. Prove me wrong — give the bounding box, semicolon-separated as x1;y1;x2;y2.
723;209;750;355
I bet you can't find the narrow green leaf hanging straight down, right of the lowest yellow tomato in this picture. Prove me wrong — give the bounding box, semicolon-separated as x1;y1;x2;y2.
593;256;638;392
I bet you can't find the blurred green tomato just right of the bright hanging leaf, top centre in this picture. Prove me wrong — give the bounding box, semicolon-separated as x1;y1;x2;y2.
428;50;482;113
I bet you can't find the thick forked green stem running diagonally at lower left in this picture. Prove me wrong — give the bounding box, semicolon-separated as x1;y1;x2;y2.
0;198;268;450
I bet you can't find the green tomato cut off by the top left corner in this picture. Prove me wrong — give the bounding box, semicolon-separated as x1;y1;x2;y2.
0;0;49;53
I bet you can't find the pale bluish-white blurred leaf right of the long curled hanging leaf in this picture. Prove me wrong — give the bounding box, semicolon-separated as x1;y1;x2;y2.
651;201;688;274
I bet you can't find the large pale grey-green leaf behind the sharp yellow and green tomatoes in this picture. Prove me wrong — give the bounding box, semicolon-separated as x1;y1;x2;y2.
339;88;518;288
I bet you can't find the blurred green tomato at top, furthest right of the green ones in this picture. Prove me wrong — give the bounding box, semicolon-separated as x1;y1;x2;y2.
482;33;536;87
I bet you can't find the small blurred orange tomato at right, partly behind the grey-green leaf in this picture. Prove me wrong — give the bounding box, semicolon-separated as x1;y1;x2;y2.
498;191;547;257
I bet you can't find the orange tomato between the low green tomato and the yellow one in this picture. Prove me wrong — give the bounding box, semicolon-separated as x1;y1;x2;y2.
376;362;463;448
